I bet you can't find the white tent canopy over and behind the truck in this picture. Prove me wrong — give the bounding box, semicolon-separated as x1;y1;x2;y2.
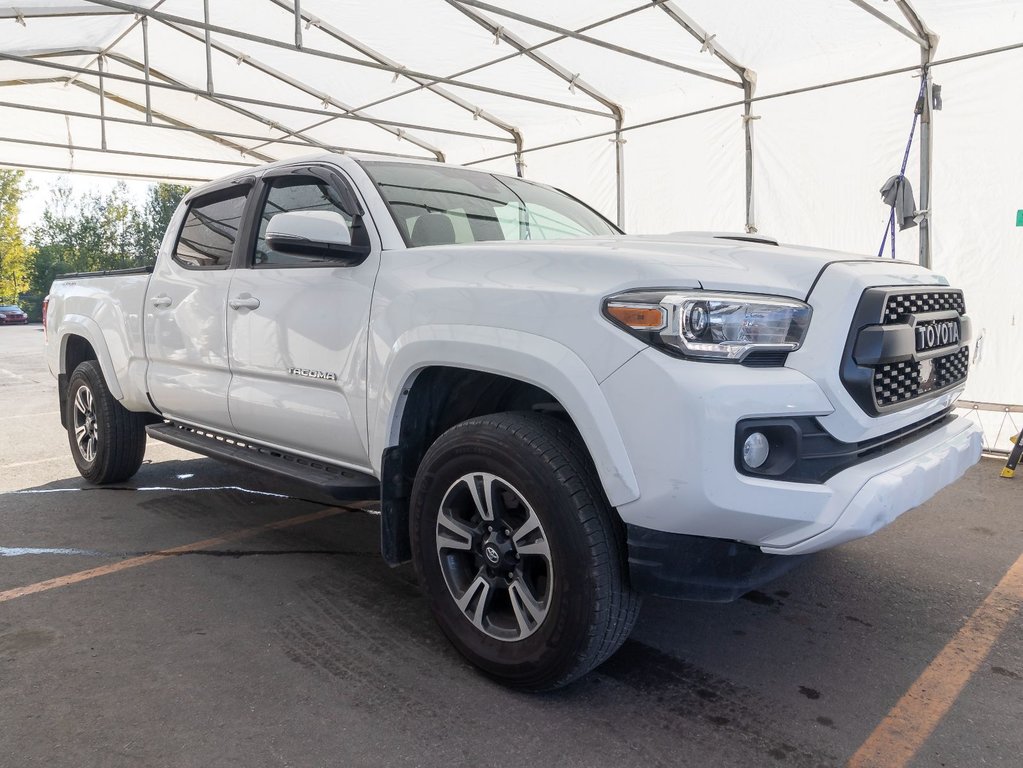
0;0;1023;441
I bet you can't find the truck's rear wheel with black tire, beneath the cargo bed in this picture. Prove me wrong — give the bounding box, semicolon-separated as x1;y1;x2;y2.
64;360;145;485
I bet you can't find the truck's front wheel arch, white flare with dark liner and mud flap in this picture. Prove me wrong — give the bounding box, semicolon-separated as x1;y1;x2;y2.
371;326;639;564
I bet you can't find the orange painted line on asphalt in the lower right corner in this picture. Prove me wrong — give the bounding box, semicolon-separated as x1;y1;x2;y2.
847;555;1023;768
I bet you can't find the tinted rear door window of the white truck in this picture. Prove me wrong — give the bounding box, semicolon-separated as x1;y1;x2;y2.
174;187;249;269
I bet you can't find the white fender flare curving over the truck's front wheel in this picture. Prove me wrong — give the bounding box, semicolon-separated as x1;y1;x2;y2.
370;325;639;507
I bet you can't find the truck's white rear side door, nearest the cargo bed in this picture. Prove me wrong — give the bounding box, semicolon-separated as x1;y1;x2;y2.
143;179;253;431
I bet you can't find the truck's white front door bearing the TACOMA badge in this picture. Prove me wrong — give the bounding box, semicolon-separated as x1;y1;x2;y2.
227;166;381;469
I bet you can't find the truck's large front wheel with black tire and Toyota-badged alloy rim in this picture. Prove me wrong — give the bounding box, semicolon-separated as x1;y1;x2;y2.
410;413;640;691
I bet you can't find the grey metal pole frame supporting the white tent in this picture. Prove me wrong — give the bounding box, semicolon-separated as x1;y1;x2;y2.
0;0;940;265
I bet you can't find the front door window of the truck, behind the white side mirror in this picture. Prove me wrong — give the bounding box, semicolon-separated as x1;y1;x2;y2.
253;176;369;267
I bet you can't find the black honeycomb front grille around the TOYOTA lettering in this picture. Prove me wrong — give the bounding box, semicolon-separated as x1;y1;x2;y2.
842;288;970;415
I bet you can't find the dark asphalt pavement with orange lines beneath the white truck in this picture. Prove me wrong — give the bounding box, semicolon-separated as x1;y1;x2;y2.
0;325;1023;768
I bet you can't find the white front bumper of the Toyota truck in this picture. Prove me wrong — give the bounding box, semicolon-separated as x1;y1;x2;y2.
602;350;981;555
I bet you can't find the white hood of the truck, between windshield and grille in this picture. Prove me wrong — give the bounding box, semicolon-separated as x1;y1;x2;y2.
427;232;924;299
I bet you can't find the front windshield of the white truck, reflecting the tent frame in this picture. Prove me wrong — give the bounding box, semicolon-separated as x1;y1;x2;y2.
362;162;619;247
